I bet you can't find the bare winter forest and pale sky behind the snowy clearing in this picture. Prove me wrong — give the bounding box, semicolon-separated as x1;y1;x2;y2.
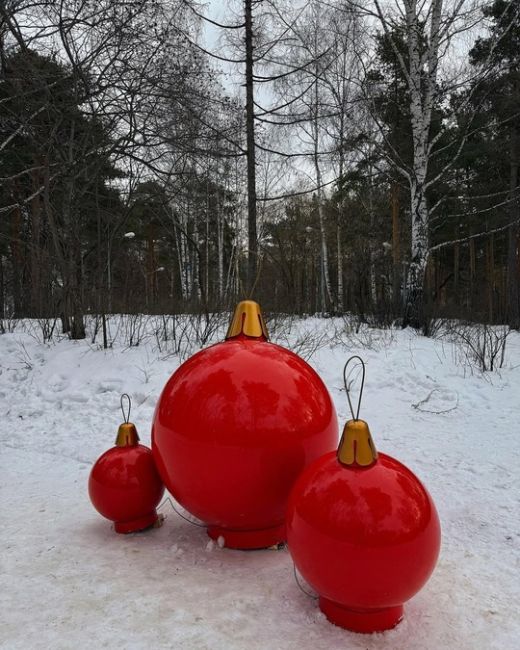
0;0;520;340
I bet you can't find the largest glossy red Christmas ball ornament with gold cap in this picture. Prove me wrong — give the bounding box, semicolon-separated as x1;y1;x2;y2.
152;301;338;549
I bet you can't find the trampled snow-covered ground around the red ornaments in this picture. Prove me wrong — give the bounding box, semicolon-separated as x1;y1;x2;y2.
0;312;520;650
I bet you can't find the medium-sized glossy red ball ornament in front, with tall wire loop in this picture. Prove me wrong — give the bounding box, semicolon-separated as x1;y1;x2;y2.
287;357;440;632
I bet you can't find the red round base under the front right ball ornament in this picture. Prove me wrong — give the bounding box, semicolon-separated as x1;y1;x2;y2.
320;596;403;634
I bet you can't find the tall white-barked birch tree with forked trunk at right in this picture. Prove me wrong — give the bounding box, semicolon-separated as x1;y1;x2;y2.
358;0;479;328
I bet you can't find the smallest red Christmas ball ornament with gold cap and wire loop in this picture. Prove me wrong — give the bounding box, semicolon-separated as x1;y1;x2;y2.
88;395;164;533
